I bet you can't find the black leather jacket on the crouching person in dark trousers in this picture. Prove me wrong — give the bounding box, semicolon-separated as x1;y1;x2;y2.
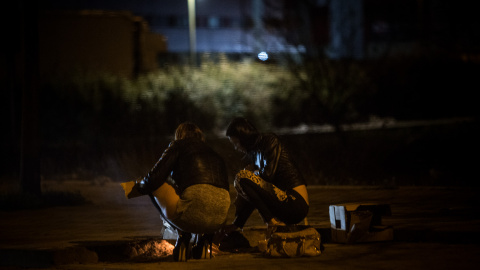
247;133;306;190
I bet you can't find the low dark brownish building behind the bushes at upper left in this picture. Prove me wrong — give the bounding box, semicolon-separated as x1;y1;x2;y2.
39;10;167;78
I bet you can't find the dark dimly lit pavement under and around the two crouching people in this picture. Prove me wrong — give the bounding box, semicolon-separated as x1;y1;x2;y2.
0;181;480;269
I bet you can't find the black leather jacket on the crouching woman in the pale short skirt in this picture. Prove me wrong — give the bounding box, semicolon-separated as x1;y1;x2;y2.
136;138;229;194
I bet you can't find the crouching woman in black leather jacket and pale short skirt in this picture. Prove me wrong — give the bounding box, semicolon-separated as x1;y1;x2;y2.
134;122;230;261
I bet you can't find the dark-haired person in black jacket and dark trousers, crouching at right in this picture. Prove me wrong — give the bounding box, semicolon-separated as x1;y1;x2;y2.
226;118;309;231
